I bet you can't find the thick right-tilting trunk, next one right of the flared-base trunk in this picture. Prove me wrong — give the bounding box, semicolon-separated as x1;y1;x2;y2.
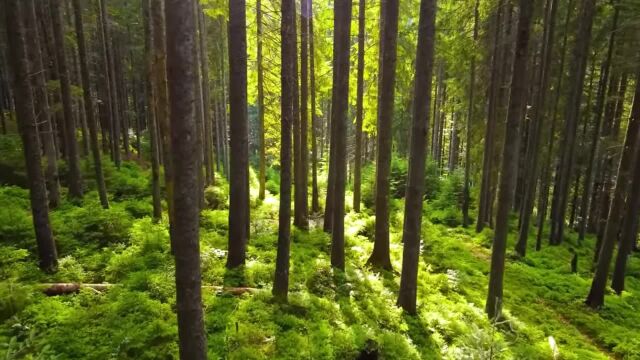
398;0;436;314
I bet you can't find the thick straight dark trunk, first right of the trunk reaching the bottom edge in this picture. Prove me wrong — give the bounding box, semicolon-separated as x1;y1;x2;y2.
227;0;249;269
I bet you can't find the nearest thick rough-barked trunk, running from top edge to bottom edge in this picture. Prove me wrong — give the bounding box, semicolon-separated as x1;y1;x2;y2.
165;0;207;360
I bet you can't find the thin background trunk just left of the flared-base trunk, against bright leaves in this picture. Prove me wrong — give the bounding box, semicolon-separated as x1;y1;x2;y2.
353;0;366;212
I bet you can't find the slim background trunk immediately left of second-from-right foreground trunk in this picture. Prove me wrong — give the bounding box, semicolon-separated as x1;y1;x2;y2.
476;0;504;232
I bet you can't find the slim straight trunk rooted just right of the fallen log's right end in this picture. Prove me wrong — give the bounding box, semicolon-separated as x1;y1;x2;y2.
273;0;296;301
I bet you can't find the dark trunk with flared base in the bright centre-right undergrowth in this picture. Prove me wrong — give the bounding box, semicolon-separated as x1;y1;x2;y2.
367;0;400;270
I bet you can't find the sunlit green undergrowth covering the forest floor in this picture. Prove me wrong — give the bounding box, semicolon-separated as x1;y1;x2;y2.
0;156;640;359
